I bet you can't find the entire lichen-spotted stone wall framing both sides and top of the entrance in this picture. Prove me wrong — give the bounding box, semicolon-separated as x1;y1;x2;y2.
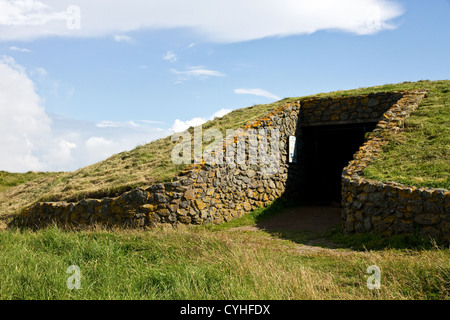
17;92;449;241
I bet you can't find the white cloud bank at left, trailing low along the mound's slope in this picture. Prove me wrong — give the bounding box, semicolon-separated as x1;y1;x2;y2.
0;56;172;172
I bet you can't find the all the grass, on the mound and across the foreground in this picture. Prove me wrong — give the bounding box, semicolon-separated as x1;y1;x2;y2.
0;81;450;300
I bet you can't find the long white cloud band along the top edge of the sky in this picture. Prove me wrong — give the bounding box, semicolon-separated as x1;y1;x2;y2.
0;0;404;42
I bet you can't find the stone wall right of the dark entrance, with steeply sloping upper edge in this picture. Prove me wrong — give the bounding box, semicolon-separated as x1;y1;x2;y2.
342;91;450;241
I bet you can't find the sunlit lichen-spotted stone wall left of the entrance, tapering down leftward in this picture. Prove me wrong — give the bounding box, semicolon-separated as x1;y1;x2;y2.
18;103;300;227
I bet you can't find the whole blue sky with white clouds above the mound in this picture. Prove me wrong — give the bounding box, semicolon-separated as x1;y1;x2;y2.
0;0;450;172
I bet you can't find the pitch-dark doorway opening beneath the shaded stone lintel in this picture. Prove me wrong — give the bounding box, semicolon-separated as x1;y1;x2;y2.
301;123;376;205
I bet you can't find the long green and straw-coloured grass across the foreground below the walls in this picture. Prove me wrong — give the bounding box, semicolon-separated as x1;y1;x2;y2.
0;222;450;300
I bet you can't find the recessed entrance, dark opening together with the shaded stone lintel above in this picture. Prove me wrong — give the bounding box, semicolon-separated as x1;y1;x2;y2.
286;92;403;206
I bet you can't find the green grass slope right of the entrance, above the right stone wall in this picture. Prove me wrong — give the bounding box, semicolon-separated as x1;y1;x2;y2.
364;81;450;190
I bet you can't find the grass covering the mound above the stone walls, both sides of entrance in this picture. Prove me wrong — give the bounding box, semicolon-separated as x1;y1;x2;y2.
0;80;450;225
